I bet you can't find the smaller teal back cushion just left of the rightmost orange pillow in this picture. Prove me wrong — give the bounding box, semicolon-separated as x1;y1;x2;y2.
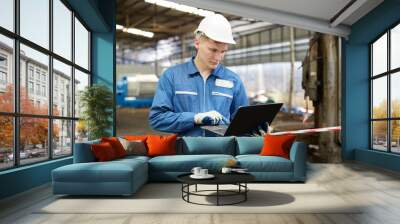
236;137;264;155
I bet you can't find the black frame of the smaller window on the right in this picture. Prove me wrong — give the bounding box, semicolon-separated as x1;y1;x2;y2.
368;21;400;155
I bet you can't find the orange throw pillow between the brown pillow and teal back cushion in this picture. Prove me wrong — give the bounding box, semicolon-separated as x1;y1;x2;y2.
146;135;178;156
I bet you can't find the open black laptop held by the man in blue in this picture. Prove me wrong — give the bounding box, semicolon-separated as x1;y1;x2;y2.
201;103;283;136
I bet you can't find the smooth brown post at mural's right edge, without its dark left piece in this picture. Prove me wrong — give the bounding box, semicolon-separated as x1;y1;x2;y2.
316;34;342;163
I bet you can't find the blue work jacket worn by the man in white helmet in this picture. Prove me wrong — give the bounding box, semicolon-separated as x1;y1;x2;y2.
149;58;248;136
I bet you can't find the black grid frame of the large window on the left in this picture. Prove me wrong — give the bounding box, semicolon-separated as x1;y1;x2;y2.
0;0;93;172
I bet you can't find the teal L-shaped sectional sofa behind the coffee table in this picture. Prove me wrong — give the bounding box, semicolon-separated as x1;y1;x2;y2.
52;137;307;195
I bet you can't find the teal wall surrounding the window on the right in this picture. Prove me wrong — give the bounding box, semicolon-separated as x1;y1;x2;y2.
342;0;400;170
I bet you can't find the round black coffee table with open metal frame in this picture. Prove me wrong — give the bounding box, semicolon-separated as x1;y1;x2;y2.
177;173;255;206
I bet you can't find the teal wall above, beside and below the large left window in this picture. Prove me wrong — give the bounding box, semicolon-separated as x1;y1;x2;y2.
0;0;116;199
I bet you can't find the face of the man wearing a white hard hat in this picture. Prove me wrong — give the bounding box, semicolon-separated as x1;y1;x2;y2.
195;37;228;70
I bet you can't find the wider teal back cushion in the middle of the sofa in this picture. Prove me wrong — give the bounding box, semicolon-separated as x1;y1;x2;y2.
178;137;235;155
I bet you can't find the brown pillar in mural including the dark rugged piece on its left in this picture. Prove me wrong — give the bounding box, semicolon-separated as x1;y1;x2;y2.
302;33;342;163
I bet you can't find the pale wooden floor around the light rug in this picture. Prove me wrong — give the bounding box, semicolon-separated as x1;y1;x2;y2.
0;163;400;224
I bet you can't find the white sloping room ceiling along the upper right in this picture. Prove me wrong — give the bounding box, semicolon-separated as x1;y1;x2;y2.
172;0;383;37
